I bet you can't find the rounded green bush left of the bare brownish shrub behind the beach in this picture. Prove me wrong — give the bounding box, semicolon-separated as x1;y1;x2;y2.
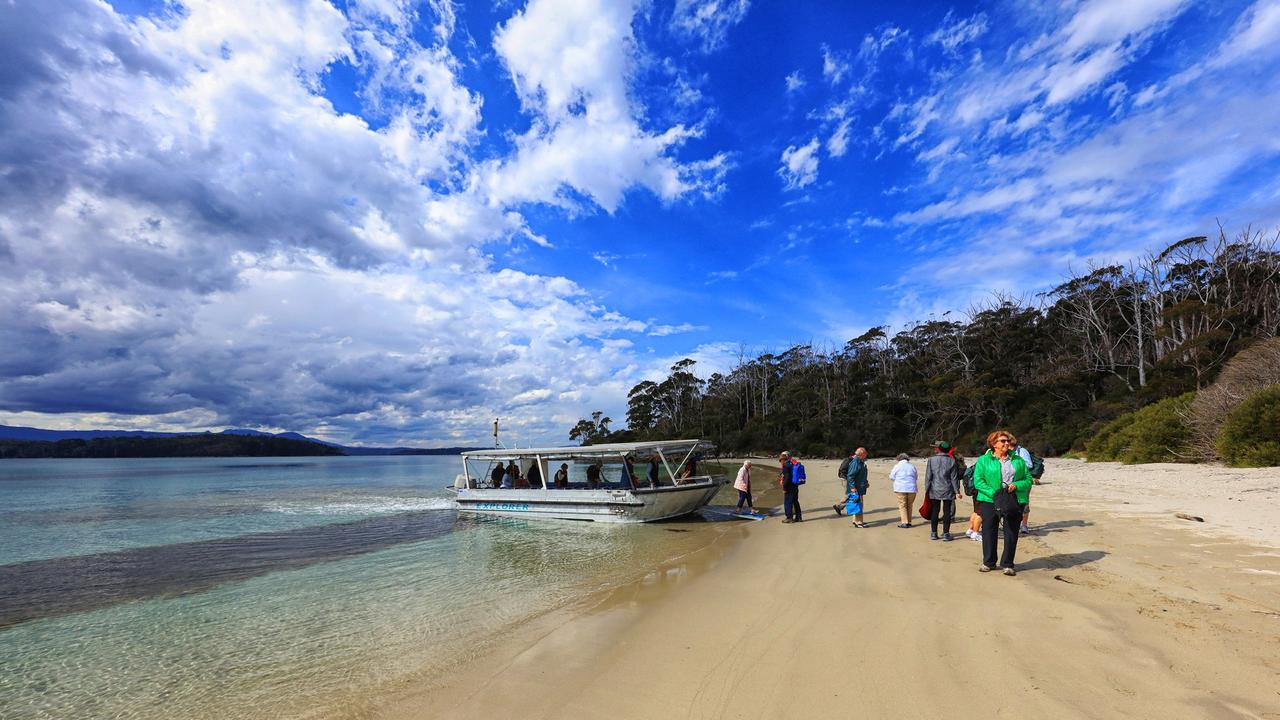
1087;392;1196;465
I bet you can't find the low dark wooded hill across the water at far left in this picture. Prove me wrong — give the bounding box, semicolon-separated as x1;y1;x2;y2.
0;433;342;457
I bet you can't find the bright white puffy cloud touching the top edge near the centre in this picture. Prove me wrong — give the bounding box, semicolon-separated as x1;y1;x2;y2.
481;0;724;213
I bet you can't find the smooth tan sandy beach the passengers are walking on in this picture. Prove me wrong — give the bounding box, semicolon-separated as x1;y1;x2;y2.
379;460;1280;720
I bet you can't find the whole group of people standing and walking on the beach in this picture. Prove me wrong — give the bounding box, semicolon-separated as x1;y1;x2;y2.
733;430;1039;575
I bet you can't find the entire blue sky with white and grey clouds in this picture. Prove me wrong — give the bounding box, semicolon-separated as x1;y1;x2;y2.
0;0;1280;447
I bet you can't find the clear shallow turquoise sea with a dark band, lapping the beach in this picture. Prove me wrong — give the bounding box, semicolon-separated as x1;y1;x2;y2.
0;456;730;720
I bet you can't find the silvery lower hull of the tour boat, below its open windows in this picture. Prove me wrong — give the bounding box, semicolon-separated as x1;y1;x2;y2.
457;478;723;523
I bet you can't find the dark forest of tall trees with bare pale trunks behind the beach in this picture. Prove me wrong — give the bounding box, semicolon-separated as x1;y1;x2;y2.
570;228;1280;462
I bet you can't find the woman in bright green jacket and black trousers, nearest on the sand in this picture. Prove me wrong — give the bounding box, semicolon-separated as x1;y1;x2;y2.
973;430;1032;575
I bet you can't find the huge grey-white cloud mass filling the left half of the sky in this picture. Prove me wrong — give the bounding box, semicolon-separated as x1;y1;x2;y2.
0;0;728;445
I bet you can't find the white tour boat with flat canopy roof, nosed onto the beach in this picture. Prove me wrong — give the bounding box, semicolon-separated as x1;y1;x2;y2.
453;439;724;523
